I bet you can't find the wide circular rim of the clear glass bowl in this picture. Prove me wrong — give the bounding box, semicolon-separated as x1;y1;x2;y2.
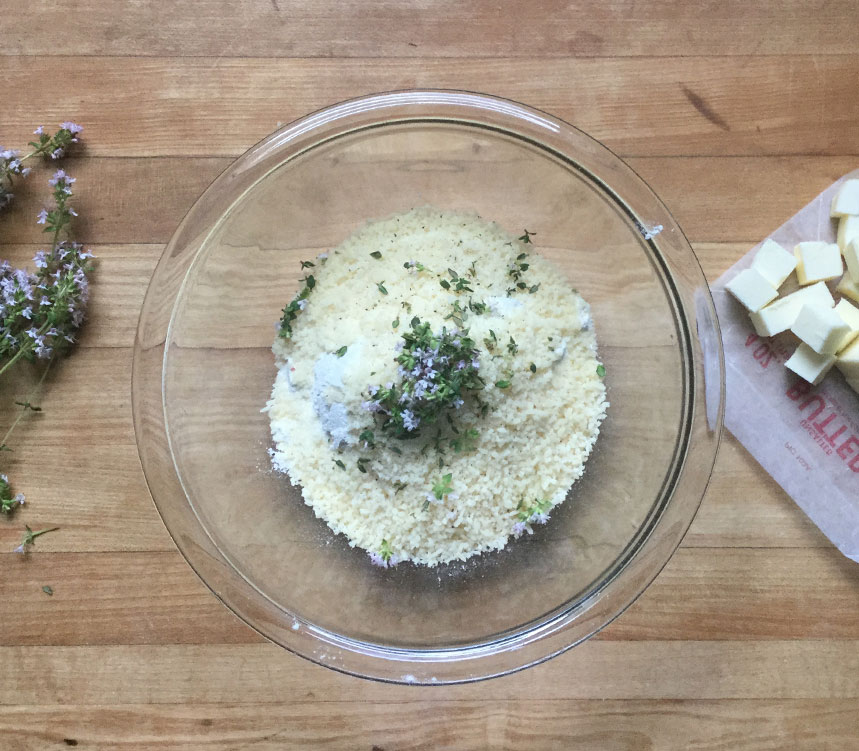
132;89;725;685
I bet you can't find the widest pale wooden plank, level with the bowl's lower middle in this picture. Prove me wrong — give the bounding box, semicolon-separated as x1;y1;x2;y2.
0;340;830;552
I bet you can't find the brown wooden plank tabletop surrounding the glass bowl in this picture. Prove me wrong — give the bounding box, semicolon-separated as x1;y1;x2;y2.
0;0;859;751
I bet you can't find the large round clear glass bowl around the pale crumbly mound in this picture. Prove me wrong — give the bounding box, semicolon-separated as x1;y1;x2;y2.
133;91;724;683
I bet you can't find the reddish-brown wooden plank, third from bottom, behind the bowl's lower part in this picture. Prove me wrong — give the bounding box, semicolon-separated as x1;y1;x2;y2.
0;548;859;646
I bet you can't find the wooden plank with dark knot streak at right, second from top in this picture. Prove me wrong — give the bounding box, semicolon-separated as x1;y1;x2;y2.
0;58;859;159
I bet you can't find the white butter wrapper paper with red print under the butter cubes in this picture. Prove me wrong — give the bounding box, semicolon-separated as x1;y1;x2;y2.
711;170;859;561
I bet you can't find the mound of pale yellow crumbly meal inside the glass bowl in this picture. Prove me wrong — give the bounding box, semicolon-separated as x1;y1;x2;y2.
265;208;608;565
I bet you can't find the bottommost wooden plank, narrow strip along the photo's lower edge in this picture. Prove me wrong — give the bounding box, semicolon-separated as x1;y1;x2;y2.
0;695;859;751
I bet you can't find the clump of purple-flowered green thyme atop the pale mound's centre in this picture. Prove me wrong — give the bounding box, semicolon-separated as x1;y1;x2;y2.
362;316;484;439
